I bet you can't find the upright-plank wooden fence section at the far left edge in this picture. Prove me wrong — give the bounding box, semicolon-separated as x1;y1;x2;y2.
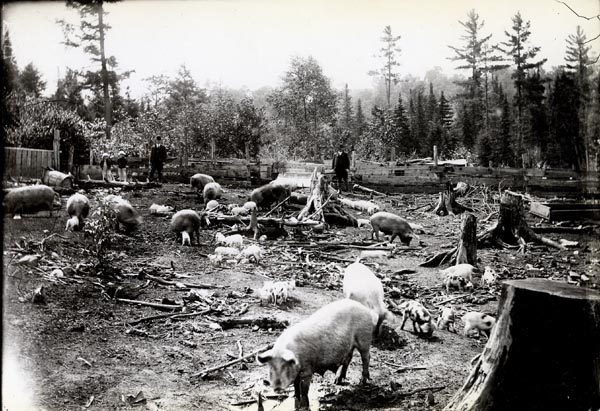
4;147;55;178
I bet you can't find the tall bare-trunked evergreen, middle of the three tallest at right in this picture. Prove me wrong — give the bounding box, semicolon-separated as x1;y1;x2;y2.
498;12;547;156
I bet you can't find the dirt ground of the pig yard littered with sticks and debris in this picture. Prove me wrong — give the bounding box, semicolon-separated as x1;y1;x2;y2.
2;184;600;410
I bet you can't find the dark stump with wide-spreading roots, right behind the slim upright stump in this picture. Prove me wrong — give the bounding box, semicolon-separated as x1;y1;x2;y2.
477;191;565;252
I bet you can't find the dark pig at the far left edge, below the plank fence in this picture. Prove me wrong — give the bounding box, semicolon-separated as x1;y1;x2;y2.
2;184;60;215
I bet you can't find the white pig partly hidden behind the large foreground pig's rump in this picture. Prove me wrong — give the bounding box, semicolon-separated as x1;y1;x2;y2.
343;262;393;336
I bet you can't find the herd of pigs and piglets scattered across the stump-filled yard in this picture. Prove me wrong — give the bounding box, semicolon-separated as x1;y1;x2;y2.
3;174;496;407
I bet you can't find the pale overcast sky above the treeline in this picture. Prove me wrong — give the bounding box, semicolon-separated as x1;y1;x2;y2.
3;0;600;97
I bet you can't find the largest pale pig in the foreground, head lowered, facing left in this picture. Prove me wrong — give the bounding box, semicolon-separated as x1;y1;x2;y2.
257;298;377;407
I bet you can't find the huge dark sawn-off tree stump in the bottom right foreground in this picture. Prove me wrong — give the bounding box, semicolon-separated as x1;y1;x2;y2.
445;279;600;411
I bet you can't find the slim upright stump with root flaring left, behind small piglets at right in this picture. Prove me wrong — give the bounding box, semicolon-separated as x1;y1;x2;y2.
421;213;477;267
